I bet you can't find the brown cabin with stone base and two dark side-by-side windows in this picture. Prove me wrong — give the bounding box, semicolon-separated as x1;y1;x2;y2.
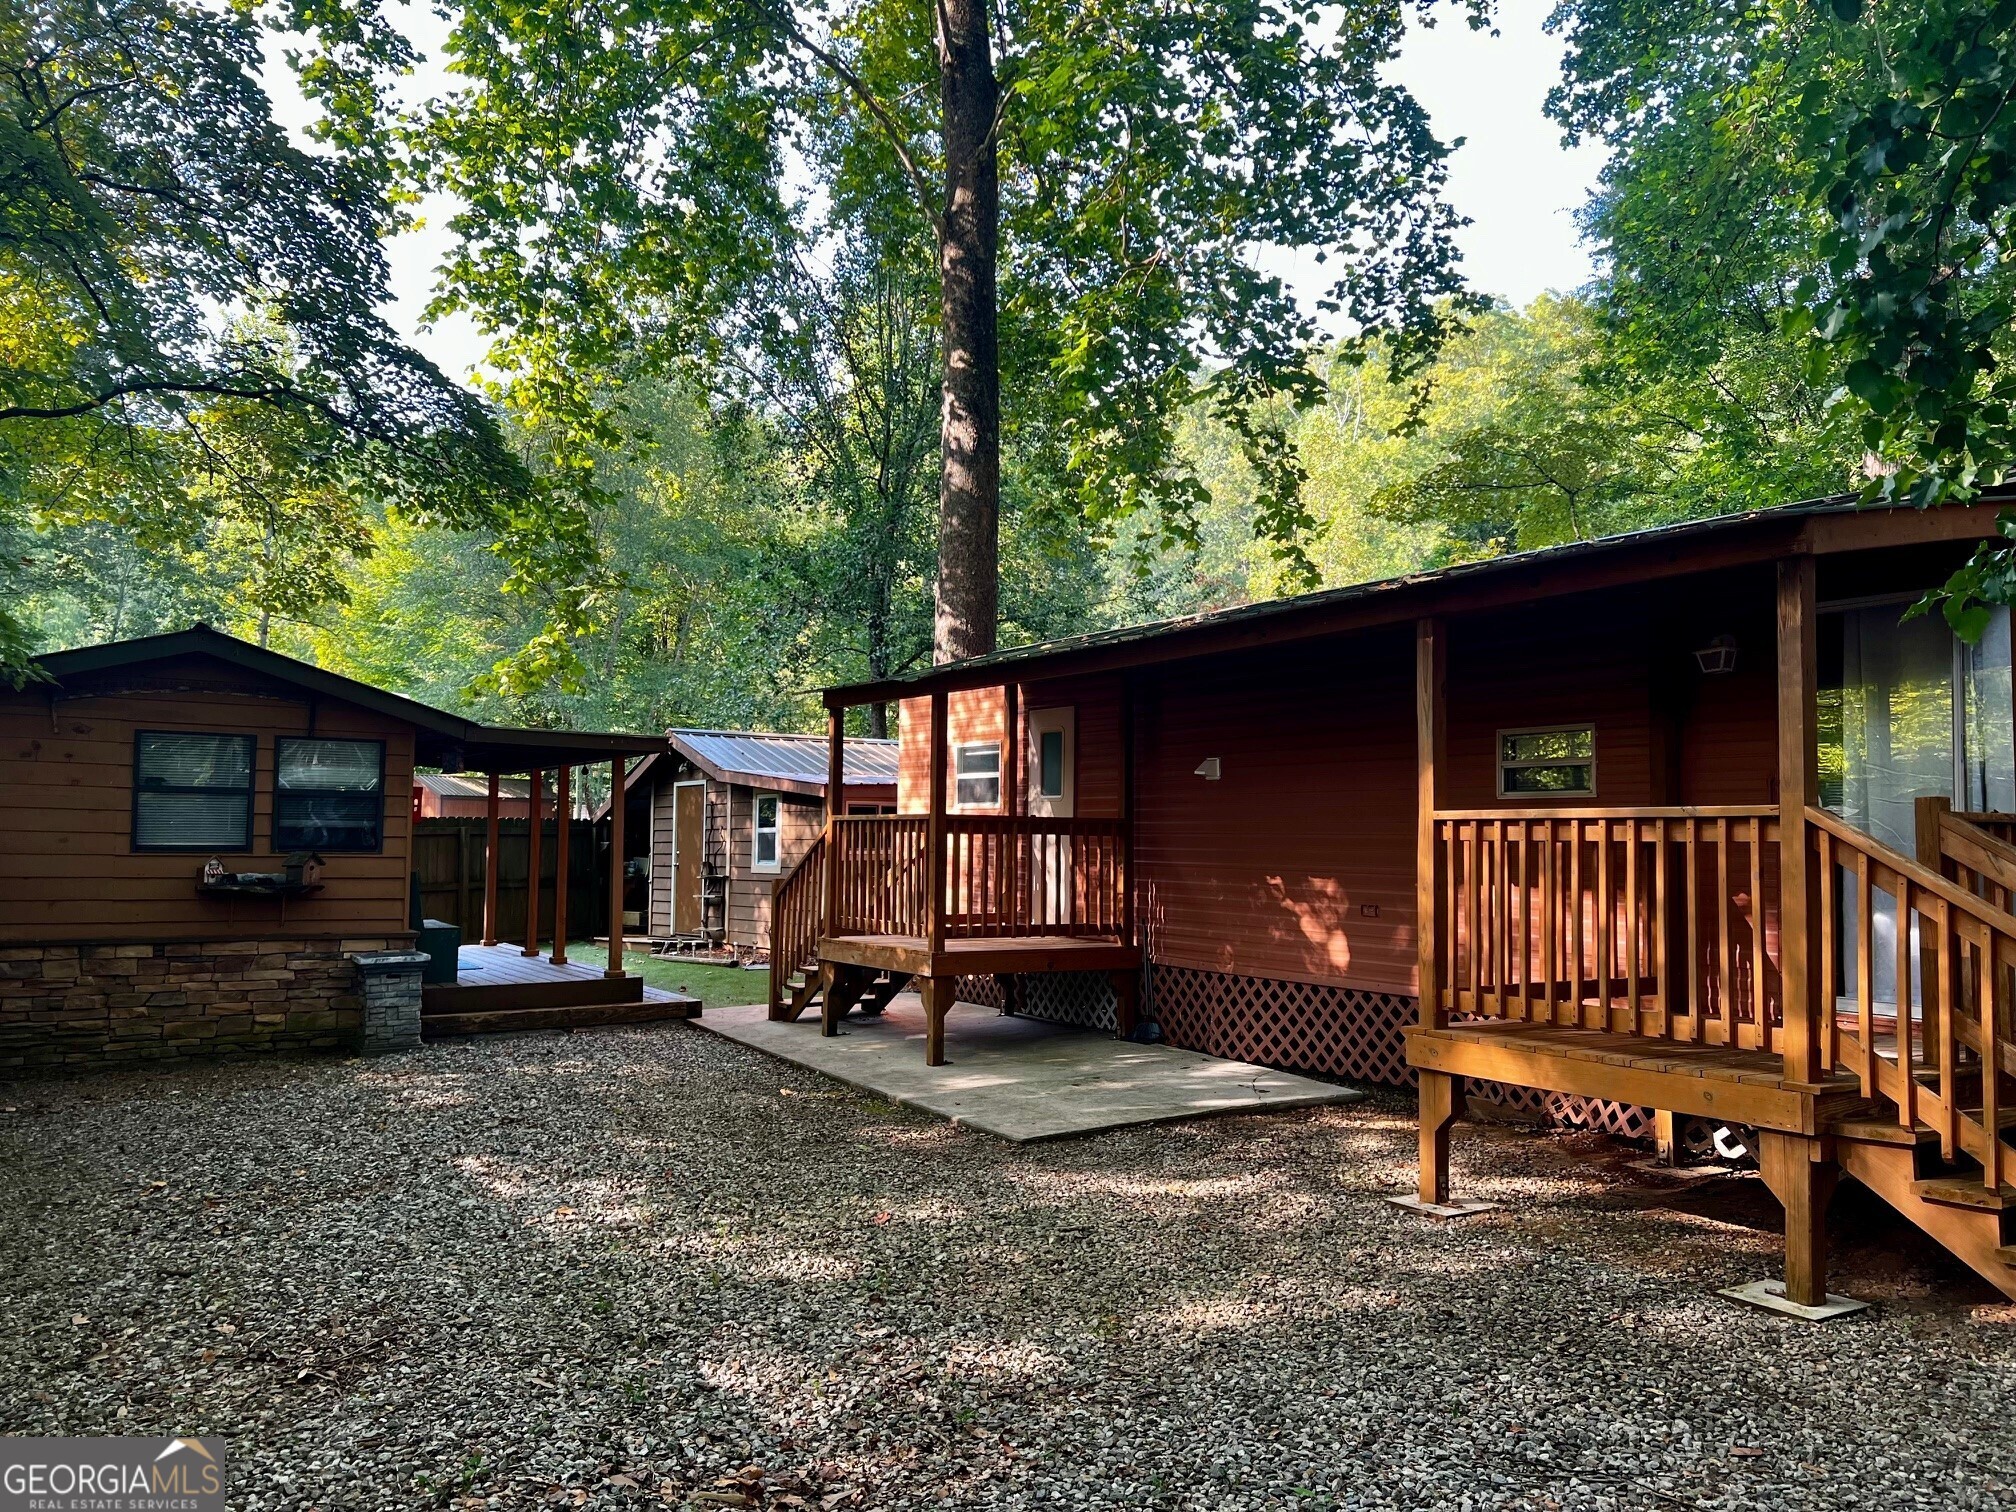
0;625;653;1066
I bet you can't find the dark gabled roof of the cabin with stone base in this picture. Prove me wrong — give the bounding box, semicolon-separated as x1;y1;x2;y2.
28;625;663;772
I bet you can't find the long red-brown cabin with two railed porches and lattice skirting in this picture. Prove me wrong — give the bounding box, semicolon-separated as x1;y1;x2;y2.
772;502;2016;1304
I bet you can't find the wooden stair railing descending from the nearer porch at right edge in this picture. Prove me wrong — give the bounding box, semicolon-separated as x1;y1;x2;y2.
1806;808;2016;1189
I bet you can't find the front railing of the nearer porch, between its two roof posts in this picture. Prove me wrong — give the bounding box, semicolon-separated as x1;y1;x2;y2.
1435;808;1778;1048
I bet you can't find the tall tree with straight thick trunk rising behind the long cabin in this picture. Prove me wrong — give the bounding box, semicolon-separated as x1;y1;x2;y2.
419;0;1476;657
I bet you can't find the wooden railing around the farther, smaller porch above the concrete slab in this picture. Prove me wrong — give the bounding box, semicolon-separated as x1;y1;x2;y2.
829;814;1127;939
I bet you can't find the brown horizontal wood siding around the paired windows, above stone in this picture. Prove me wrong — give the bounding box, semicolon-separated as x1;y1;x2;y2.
0;669;413;941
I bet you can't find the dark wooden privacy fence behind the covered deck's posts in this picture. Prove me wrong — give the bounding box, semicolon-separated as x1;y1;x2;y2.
413;818;609;941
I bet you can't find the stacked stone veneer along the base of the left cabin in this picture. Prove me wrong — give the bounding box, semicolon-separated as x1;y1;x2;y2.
0;937;419;1075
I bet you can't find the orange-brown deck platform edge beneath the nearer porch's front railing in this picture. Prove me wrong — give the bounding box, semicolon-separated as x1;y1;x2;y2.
1405;1020;1861;1135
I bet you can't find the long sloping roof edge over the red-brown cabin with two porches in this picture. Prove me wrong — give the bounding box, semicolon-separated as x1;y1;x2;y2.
825;490;2016;710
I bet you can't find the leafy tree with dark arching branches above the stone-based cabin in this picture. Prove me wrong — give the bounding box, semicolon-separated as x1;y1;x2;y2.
0;0;560;677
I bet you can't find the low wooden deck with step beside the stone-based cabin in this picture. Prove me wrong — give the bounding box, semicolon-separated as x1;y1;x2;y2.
419;946;700;1040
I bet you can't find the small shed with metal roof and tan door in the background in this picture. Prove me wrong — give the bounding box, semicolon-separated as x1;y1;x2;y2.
605;730;897;954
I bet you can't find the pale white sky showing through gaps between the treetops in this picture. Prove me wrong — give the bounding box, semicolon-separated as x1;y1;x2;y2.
306;0;1603;379
